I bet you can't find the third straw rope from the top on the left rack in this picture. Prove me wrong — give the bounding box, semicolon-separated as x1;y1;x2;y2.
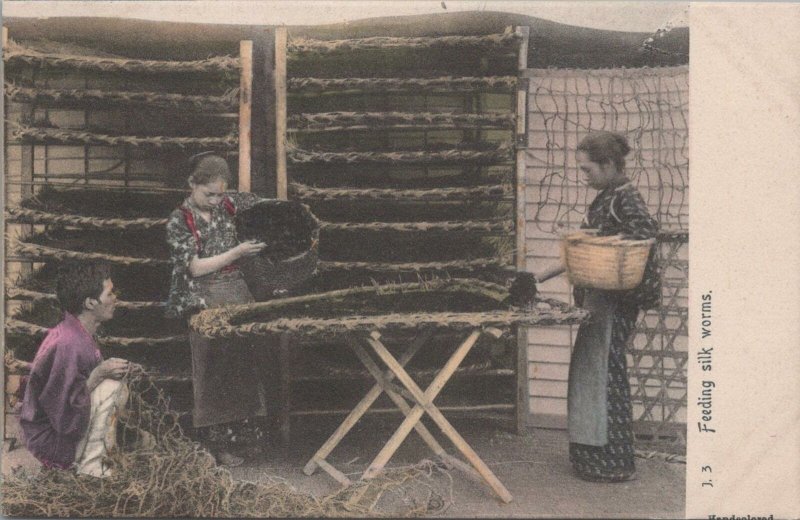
9;124;238;149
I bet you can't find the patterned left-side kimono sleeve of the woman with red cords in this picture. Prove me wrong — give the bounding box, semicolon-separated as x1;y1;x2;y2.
166;210;205;318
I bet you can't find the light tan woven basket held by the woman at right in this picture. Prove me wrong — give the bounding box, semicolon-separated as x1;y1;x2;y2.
561;231;655;291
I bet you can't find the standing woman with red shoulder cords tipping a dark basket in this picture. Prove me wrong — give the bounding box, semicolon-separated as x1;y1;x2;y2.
166;152;266;466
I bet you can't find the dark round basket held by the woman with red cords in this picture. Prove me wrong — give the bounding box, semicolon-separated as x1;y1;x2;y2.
237;200;319;301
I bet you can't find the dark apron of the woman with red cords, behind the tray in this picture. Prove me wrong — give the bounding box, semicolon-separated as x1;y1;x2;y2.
189;270;265;427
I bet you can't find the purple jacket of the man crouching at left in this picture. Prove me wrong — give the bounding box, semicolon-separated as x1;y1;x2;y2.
20;313;103;469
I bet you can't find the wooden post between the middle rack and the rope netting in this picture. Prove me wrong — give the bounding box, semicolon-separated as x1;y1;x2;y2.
514;27;530;435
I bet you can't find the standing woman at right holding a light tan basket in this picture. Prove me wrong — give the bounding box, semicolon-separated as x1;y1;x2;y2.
536;132;661;482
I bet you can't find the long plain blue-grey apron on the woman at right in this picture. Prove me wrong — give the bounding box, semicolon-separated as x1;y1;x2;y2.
567;289;617;446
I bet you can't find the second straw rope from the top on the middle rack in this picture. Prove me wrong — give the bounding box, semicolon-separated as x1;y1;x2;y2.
288;76;517;95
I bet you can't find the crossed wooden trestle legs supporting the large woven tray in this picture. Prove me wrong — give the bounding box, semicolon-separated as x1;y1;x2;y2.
303;329;512;502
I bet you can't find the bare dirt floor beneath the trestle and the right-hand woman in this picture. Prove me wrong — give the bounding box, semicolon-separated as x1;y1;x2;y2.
3;419;685;519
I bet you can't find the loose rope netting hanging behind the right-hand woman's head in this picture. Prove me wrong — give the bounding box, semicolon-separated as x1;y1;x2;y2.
527;67;689;232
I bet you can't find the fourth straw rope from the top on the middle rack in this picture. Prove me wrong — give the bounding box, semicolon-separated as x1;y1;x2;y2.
286;145;512;164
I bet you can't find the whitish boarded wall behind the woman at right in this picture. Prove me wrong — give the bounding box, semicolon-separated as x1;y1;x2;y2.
525;67;689;426
